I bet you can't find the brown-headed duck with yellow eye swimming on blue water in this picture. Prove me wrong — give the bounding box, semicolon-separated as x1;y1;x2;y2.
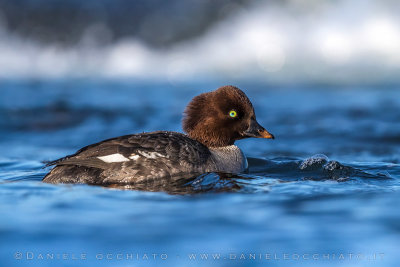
42;85;274;185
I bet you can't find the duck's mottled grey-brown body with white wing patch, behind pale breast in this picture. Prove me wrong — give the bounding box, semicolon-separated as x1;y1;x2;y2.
43;132;211;184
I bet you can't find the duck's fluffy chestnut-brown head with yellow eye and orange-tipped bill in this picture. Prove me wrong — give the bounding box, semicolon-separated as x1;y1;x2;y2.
182;85;274;147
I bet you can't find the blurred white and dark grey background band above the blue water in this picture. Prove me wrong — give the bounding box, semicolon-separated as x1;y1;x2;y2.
0;0;400;84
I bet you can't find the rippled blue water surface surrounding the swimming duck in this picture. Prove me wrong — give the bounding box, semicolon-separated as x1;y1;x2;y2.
0;80;400;266
